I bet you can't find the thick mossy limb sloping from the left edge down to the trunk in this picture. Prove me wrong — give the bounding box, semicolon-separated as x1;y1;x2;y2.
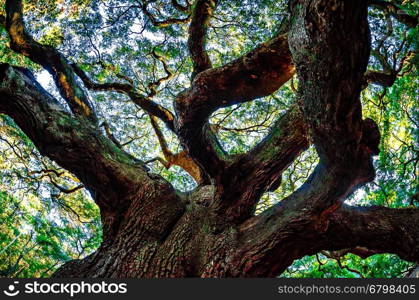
0;64;145;206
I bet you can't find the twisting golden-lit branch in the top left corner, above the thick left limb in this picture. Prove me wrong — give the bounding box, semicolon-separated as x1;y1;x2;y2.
6;0;97;123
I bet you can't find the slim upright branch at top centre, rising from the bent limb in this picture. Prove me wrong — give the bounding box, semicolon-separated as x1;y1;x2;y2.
188;0;217;79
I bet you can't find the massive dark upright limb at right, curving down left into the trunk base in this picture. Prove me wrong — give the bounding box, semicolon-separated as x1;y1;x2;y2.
213;0;379;276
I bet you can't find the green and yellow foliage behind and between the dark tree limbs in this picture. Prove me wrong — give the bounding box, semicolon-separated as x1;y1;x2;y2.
0;0;419;277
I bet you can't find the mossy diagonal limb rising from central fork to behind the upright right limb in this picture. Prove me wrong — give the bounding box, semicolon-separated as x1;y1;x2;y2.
213;105;309;223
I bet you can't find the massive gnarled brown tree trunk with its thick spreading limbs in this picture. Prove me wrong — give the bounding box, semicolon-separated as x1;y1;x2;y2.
0;0;419;277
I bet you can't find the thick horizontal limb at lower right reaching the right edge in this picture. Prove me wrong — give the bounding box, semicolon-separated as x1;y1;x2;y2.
324;205;419;263
